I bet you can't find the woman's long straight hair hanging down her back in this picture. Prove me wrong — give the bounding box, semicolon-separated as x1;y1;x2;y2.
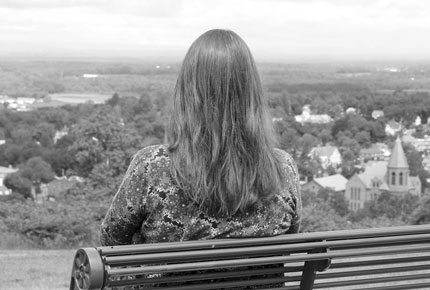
168;29;281;215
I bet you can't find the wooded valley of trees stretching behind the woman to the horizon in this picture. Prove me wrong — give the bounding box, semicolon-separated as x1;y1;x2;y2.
0;61;430;248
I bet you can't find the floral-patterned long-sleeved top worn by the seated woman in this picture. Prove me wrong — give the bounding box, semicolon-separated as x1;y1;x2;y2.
100;145;301;246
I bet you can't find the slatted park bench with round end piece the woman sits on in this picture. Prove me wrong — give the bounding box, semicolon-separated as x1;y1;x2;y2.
70;225;430;290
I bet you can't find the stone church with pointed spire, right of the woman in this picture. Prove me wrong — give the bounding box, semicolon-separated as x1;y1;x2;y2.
345;137;421;211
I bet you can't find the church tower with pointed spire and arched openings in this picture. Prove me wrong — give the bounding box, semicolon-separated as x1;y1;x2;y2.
387;136;409;193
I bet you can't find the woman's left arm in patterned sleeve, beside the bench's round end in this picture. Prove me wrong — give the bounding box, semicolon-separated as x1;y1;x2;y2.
100;152;147;246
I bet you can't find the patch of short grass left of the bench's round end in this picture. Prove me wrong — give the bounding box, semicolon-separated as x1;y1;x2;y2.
0;250;75;290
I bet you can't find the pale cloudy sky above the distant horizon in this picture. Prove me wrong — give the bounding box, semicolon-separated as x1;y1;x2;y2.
0;0;430;61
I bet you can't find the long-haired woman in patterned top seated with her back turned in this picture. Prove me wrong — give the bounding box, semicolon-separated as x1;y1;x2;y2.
101;29;301;246
